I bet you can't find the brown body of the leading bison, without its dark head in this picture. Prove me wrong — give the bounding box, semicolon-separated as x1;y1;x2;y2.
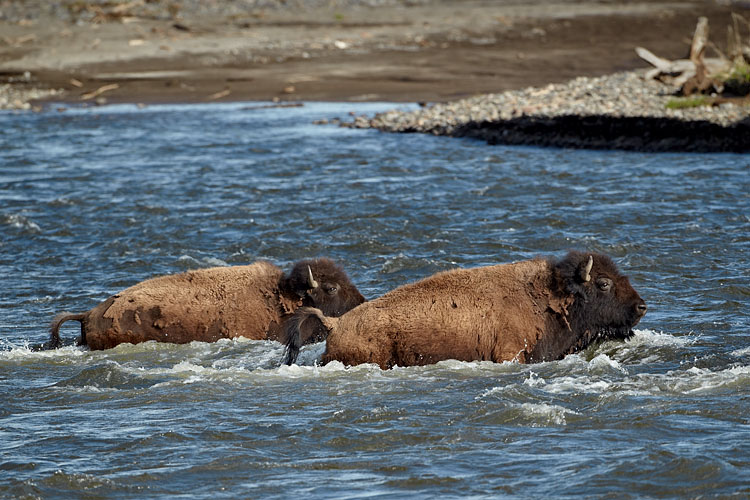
323;260;549;368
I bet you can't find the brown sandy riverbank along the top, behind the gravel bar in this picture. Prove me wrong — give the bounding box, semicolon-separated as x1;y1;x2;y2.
0;0;749;106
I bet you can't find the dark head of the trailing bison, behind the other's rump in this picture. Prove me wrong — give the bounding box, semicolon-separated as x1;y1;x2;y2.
284;258;365;316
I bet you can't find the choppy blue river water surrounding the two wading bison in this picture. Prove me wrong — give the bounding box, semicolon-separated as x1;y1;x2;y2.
0;104;750;498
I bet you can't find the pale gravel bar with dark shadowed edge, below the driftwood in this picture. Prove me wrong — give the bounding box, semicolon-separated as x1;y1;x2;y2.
341;71;750;152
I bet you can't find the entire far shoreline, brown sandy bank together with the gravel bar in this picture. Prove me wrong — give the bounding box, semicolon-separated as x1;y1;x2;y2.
0;0;750;151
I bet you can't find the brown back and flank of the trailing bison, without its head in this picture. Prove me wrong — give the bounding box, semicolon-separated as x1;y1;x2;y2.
84;262;292;349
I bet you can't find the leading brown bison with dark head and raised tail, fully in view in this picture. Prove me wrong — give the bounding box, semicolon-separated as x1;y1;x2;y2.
284;252;646;369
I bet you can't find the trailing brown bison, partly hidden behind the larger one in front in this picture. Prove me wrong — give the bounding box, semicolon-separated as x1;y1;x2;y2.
50;258;365;349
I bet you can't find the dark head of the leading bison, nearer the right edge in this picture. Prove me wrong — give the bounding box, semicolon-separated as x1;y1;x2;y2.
554;252;647;350
